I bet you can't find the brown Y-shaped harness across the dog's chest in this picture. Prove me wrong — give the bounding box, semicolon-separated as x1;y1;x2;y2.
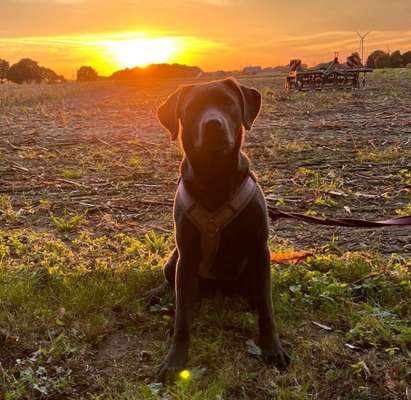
177;175;257;279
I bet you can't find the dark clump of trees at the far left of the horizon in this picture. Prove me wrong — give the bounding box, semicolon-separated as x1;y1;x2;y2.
0;58;66;84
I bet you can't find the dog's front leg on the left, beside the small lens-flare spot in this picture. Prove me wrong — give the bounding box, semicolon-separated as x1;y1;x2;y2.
159;253;199;380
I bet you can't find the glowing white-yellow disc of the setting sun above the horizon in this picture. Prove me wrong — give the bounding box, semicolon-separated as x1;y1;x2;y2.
107;38;179;68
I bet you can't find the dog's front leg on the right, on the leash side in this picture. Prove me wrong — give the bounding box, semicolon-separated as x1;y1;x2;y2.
254;246;290;369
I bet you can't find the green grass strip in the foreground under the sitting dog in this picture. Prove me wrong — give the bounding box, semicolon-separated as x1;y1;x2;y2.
0;230;411;400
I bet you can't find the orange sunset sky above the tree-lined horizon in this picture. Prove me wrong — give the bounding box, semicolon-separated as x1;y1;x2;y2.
0;0;411;78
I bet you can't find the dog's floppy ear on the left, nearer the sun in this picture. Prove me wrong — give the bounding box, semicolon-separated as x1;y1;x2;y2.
157;87;186;140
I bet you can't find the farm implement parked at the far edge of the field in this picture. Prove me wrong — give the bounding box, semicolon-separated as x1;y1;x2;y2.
285;53;373;91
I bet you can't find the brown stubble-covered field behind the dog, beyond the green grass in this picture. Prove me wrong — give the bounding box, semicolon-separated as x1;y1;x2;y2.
0;75;411;255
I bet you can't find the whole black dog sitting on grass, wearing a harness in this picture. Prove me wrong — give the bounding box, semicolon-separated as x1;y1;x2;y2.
158;79;289;378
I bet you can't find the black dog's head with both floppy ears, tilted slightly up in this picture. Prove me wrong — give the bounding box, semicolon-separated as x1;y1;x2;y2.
157;78;261;157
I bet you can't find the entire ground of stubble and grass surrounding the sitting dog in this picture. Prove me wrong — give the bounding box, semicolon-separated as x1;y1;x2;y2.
0;70;411;400
